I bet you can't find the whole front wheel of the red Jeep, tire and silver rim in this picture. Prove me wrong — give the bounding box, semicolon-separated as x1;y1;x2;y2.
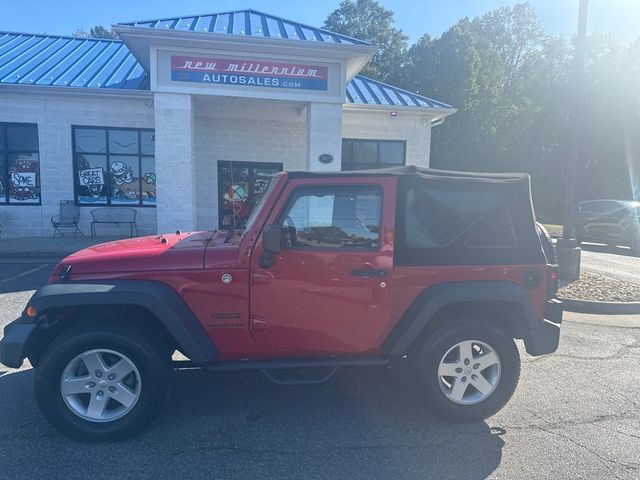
35;323;170;442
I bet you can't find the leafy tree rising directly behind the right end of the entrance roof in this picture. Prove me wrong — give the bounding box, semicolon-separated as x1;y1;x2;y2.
324;0;408;81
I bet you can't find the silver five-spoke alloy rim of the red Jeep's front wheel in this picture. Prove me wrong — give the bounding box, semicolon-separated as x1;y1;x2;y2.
60;349;142;422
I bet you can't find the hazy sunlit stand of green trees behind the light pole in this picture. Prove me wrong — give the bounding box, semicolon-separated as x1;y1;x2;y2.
399;4;640;221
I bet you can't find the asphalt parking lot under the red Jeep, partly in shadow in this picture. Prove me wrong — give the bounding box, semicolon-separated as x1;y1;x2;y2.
0;260;640;479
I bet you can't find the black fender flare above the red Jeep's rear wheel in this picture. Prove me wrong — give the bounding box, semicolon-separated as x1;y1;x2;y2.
382;281;541;356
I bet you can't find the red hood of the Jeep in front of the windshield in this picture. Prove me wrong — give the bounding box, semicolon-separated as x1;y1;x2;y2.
50;232;238;281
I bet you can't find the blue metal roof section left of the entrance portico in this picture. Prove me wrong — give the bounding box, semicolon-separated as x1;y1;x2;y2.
0;32;149;90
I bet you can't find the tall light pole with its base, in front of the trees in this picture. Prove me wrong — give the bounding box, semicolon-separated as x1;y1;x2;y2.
557;0;589;281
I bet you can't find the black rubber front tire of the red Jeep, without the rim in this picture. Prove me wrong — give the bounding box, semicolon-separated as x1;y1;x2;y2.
35;323;171;442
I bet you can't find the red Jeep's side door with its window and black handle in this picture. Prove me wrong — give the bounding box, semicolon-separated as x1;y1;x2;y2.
250;177;395;356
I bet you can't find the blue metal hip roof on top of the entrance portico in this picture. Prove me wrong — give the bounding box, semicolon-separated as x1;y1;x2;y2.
119;10;371;45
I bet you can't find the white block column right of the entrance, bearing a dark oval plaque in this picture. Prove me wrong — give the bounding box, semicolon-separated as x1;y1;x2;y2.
307;103;342;172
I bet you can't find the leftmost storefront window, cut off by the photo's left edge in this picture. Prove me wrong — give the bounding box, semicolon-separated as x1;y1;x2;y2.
0;123;40;205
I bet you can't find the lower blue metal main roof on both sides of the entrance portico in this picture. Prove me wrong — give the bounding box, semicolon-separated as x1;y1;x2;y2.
0;28;451;108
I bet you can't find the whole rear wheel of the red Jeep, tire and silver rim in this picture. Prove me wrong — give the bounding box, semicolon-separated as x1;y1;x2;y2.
415;319;520;422
